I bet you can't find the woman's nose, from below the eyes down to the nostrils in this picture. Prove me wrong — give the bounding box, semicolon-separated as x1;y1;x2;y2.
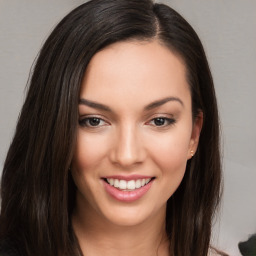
110;126;146;168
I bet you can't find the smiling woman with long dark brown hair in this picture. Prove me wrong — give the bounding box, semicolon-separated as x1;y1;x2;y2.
0;0;224;256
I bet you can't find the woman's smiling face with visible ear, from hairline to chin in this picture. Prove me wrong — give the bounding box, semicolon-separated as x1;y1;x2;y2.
72;41;202;226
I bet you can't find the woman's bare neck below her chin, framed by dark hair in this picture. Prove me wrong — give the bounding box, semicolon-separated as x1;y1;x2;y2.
73;201;169;256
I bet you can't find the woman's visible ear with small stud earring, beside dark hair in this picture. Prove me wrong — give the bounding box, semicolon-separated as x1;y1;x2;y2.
188;111;204;159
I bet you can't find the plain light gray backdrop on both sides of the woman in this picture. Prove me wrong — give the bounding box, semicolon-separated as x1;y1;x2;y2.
0;0;256;255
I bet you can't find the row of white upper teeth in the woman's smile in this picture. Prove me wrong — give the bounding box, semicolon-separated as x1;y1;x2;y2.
107;178;151;190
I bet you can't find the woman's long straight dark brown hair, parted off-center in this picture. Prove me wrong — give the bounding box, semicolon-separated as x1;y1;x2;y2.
0;0;221;256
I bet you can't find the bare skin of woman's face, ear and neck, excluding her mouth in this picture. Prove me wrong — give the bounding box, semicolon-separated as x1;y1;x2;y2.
72;41;202;256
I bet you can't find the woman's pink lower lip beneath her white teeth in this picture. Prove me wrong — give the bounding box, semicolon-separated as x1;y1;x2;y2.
103;180;154;202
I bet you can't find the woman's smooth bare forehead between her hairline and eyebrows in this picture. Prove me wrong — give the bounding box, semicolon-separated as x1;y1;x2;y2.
81;41;190;109
